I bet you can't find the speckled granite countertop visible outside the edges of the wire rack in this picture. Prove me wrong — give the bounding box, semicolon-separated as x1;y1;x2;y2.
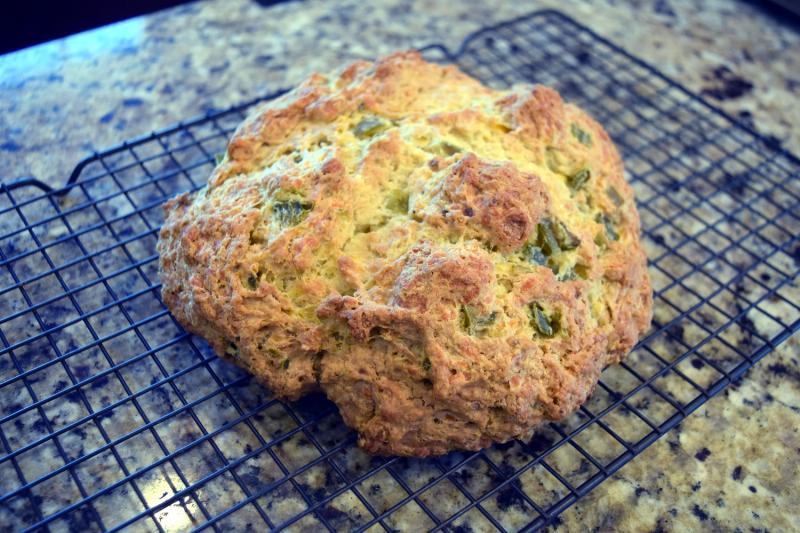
0;0;800;531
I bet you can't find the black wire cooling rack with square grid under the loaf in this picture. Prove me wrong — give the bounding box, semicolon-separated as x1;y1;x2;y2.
0;11;800;531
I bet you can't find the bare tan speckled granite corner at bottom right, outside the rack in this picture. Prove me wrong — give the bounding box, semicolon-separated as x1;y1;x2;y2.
552;336;800;531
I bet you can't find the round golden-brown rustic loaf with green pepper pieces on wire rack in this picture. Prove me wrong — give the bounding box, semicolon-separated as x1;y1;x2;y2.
158;52;652;456
